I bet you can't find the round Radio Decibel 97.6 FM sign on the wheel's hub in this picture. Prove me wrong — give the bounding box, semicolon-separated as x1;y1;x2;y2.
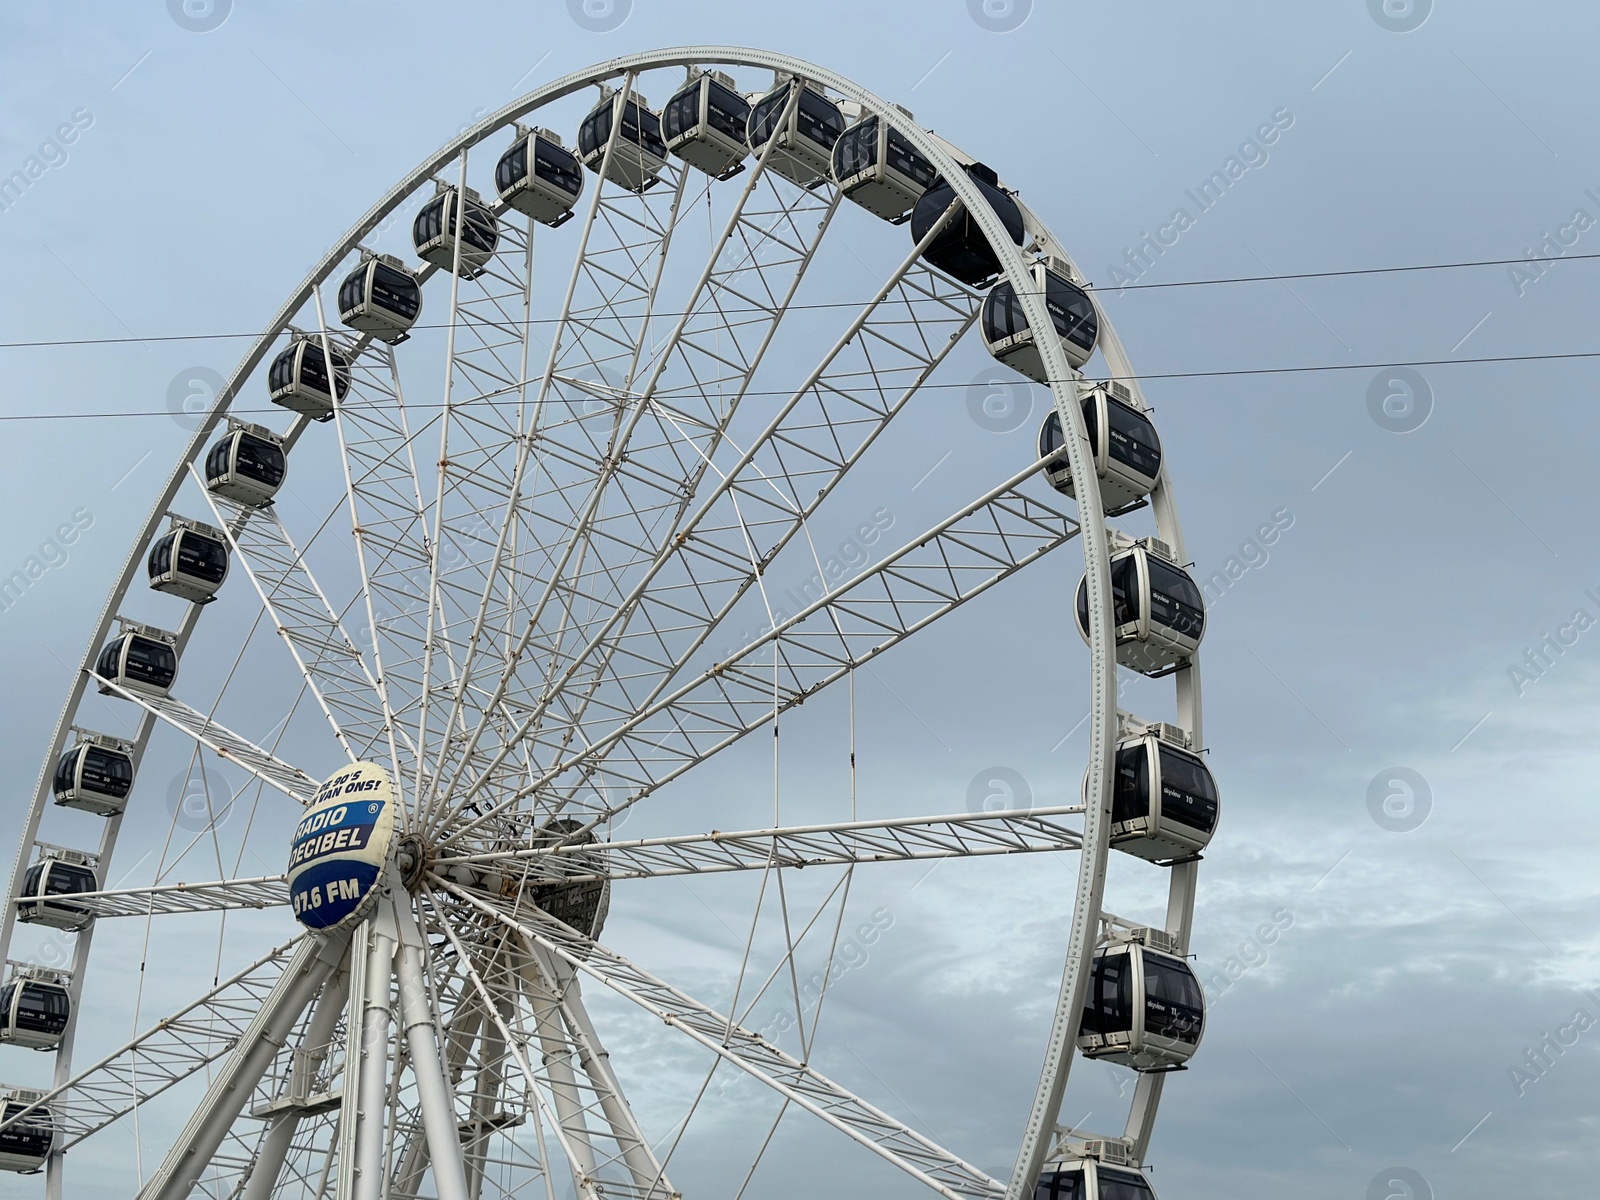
288;763;395;930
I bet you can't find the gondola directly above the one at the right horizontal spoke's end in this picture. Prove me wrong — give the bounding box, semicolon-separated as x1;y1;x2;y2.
1075;538;1205;678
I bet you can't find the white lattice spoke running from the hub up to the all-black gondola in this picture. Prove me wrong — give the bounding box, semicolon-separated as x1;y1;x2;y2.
432;210;976;838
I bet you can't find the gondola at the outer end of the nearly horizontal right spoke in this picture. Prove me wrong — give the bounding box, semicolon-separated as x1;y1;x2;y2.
1107;725;1218;862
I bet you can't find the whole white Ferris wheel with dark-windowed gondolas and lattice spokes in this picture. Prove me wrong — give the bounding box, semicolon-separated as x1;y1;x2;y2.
0;46;1218;1200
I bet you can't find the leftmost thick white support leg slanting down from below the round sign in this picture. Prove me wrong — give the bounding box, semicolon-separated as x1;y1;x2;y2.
139;934;349;1200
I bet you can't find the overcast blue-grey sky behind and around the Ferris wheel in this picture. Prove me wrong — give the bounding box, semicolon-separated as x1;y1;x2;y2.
0;0;1600;1200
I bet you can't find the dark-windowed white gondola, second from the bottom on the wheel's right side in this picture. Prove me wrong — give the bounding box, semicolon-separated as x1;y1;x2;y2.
1078;941;1205;1072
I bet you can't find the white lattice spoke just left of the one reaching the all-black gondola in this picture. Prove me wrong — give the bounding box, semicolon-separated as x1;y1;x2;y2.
432;133;838;825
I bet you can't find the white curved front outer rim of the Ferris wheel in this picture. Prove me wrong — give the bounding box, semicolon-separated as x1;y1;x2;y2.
3;46;1198;1186
